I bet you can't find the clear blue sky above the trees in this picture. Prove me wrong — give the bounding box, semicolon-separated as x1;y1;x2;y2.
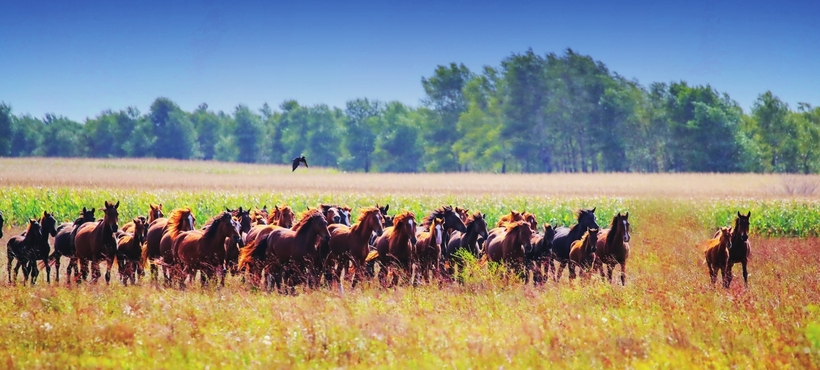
0;0;820;121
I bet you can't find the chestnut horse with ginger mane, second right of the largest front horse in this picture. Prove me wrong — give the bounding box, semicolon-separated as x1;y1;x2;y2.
374;212;417;286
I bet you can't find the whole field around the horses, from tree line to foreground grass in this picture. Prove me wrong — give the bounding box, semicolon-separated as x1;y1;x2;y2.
0;159;820;369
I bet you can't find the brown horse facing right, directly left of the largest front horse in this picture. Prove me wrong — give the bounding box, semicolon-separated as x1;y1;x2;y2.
171;212;242;288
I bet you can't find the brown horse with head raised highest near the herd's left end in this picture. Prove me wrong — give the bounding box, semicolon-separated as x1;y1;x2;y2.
74;201;120;283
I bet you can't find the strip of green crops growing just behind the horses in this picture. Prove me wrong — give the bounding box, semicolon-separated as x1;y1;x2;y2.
0;187;820;237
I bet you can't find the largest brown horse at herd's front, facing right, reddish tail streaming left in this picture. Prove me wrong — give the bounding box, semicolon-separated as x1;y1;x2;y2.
239;209;330;288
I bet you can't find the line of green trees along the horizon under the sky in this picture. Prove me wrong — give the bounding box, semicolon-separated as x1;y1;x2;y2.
0;49;820;173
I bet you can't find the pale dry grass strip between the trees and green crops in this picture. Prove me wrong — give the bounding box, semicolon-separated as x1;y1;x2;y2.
0;158;820;198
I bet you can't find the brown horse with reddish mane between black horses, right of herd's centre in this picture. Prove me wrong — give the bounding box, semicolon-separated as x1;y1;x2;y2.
484;221;532;276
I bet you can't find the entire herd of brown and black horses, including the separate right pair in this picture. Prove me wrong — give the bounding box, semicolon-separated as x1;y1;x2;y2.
0;201;751;291
